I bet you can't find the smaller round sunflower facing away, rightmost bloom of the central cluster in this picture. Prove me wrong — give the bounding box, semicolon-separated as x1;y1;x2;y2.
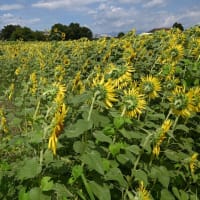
140;75;161;99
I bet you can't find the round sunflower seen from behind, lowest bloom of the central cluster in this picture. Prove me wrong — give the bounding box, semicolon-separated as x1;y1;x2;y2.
122;88;146;117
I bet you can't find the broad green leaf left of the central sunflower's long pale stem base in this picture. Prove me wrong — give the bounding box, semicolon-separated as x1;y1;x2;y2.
65;119;93;138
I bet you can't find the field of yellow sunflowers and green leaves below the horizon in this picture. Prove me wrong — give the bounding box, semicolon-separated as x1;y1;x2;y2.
0;26;200;200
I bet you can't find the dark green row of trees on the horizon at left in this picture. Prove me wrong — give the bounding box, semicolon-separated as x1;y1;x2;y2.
0;23;93;41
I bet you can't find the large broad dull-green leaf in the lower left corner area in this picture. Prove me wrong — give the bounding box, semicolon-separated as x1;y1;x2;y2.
17;158;42;180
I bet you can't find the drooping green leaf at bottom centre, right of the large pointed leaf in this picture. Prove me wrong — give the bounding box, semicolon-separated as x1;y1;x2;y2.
105;167;127;188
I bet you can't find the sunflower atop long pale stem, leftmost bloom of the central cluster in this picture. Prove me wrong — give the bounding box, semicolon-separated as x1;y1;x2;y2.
92;75;118;108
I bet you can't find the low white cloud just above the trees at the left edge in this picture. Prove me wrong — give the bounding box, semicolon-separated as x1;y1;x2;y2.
0;13;40;28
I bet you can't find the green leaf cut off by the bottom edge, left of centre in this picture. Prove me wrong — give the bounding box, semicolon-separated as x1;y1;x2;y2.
89;181;111;200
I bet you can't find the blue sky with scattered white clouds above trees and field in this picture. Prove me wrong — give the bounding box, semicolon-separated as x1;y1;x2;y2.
0;0;200;34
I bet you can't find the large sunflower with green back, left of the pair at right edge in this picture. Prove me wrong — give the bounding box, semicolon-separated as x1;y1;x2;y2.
168;86;195;118
